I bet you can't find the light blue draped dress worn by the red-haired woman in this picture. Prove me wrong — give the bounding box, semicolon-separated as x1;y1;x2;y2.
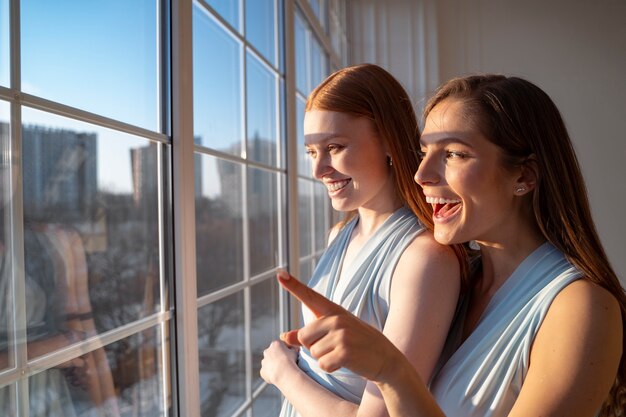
280;208;424;417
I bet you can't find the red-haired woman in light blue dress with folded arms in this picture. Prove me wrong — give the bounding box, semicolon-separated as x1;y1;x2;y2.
261;64;463;417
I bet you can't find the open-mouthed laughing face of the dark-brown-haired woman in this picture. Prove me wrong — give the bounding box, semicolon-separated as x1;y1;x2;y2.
415;99;525;245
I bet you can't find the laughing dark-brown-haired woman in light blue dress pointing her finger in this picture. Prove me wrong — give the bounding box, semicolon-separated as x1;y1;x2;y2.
280;75;626;417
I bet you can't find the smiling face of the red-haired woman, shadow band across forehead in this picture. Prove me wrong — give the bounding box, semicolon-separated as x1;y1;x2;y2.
304;110;397;211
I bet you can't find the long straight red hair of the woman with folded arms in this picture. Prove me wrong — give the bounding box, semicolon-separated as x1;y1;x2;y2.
305;64;469;289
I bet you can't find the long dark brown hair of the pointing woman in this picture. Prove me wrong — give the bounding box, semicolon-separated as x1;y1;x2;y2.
423;75;626;416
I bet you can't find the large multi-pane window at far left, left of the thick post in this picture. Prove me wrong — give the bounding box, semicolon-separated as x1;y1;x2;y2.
0;0;173;417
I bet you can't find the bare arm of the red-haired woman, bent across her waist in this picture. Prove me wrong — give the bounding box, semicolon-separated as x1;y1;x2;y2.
262;233;460;417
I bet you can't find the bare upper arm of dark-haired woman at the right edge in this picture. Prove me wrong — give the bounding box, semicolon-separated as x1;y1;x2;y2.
509;279;622;417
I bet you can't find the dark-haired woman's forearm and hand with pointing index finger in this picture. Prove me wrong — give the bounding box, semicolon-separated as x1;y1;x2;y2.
278;271;443;417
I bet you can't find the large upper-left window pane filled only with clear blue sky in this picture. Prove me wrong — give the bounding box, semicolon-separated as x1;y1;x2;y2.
20;0;159;130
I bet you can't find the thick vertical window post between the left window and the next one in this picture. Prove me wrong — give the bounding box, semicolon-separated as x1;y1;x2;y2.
171;0;200;417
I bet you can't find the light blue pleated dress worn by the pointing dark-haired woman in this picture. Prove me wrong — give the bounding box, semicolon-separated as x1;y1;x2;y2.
430;243;582;417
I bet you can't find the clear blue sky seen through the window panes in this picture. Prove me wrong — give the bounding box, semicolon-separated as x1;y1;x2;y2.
0;0;286;193
